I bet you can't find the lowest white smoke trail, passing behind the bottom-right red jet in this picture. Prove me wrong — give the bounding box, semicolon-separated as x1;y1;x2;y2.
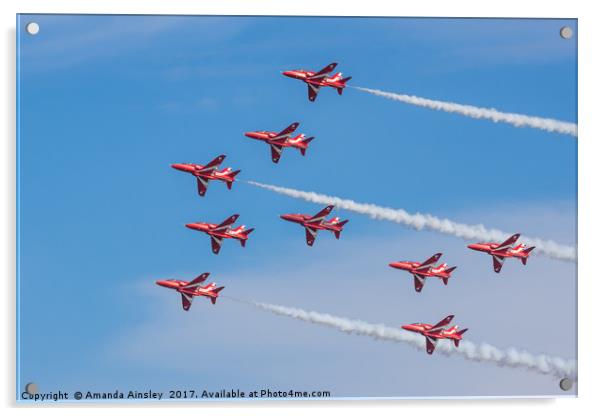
248;302;577;380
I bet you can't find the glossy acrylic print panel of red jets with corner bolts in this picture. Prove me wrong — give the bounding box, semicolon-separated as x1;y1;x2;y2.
17;15;577;403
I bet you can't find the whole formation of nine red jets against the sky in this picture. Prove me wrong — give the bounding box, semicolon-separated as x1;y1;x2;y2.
156;63;535;354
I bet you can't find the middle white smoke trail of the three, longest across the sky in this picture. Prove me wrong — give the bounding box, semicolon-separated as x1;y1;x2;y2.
247;181;577;261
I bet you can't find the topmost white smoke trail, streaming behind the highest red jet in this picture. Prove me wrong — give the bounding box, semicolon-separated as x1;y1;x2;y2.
353;87;577;137
